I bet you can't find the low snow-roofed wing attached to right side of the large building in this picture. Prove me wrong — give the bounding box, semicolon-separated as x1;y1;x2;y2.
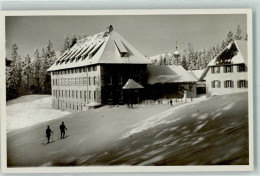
147;64;197;99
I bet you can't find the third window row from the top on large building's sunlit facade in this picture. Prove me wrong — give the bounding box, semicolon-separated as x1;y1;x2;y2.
53;90;98;102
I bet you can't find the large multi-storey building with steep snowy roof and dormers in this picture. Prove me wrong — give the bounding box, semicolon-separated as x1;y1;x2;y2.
48;25;151;111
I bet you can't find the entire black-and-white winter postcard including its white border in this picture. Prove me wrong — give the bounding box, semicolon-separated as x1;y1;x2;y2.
1;9;253;172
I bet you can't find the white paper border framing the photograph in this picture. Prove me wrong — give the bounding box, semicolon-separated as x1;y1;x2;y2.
0;9;254;173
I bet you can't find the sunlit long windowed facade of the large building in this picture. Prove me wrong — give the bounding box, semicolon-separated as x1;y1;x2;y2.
51;65;101;111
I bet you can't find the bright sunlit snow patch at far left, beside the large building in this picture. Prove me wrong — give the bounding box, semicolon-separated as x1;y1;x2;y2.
6;95;71;131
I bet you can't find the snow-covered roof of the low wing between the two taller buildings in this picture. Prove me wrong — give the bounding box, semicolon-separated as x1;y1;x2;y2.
147;64;197;84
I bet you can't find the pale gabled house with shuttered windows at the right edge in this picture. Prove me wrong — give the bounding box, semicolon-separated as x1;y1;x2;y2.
200;40;248;97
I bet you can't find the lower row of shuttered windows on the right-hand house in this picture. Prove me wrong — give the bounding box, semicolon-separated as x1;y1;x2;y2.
211;80;247;88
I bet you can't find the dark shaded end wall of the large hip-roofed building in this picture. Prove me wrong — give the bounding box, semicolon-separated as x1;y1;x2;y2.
100;64;147;104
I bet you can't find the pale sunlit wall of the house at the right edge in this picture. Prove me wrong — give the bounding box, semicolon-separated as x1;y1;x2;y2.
206;65;248;97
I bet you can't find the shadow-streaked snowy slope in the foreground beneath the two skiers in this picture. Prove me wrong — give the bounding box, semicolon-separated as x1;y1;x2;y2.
7;93;248;166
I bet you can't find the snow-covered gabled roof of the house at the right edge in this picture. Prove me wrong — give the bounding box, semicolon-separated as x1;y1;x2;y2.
199;40;248;80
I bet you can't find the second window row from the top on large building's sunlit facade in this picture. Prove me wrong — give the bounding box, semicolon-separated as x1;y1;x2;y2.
52;76;98;86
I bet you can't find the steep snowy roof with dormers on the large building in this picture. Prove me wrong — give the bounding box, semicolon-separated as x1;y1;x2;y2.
48;30;151;71
